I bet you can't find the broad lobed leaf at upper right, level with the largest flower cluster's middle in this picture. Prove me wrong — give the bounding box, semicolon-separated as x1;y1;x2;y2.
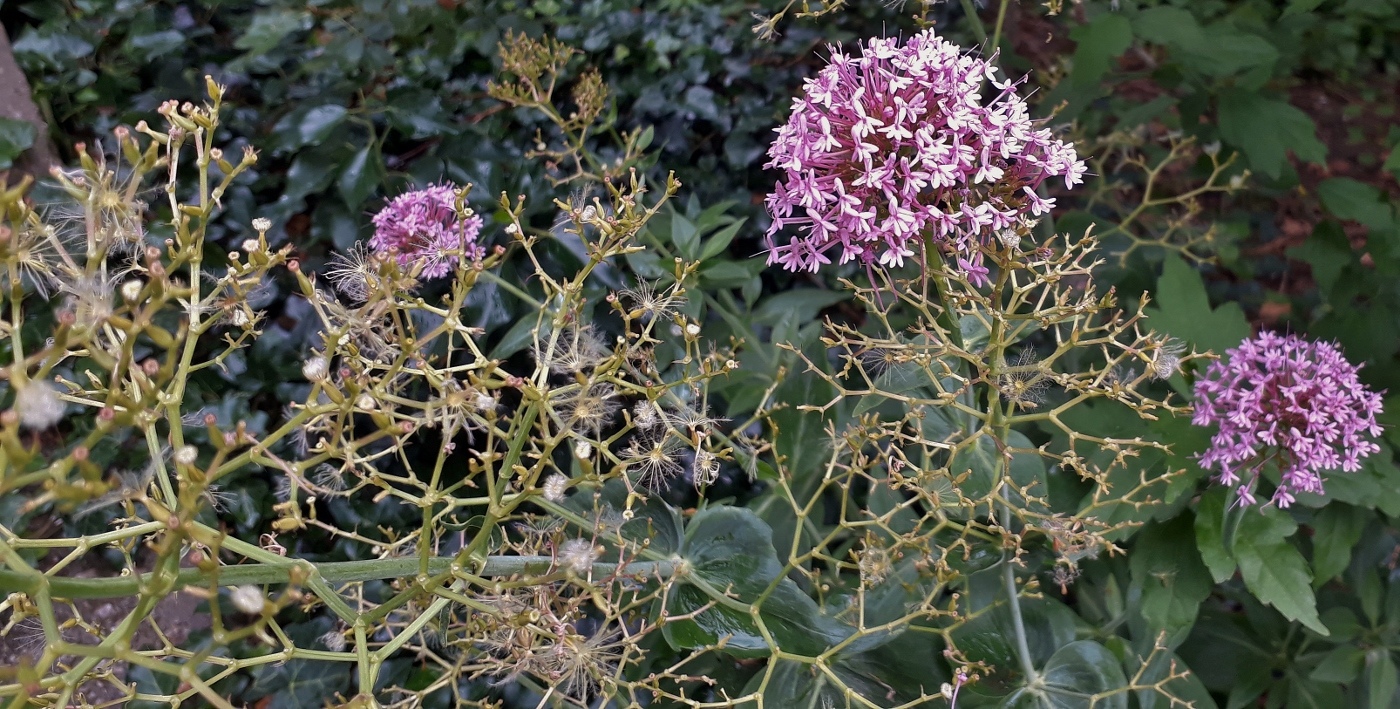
1218;91;1327;178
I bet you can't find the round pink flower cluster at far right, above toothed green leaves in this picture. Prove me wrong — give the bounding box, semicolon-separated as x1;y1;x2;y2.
1193;332;1380;507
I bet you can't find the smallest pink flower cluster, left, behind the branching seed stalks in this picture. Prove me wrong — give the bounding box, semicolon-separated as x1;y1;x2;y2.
370;184;483;279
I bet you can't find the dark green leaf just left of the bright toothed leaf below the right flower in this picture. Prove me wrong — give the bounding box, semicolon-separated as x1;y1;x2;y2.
1130;516;1211;638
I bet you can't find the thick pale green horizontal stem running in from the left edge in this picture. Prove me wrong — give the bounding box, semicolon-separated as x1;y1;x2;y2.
0;556;680;600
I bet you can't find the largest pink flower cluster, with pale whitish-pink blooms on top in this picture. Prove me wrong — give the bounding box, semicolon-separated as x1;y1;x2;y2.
764;29;1085;280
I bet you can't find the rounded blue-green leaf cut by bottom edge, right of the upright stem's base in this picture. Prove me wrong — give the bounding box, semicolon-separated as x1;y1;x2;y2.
1001;640;1128;709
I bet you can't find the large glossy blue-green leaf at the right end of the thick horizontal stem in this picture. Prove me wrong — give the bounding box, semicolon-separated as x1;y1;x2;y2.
664;507;851;657
